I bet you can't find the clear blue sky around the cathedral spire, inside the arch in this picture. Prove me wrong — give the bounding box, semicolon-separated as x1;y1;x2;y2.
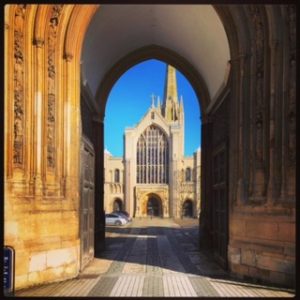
104;59;201;156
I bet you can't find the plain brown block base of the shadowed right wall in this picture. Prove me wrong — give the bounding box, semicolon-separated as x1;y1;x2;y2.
228;207;296;287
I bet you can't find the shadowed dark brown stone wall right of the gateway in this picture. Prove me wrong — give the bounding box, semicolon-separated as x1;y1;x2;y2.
228;5;296;287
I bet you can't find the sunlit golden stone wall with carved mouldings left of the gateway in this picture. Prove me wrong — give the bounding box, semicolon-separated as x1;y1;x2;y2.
4;4;98;289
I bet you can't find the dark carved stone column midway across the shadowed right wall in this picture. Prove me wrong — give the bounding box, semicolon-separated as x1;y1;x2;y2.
249;5;269;204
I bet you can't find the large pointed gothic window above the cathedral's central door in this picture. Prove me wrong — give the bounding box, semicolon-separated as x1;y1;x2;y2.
136;125;169;183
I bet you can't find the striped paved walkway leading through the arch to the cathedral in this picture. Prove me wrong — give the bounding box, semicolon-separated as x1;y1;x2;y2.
16;218;294;298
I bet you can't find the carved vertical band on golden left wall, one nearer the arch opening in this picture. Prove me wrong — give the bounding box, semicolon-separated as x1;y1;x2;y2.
47;5;63;169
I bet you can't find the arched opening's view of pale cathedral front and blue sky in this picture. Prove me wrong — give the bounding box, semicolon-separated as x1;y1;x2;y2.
104;57;201;218
